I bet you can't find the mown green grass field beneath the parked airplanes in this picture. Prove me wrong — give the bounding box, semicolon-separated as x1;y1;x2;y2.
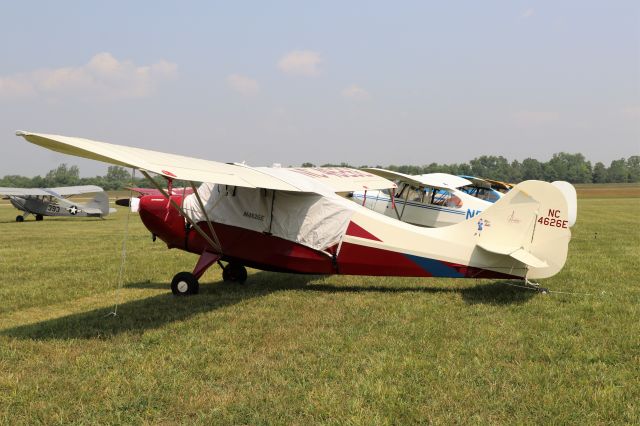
0;186;640;425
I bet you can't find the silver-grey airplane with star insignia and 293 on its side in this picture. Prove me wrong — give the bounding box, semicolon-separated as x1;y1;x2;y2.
0;185;116;222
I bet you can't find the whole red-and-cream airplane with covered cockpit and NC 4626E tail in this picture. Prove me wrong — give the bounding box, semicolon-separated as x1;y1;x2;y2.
17;131;571;295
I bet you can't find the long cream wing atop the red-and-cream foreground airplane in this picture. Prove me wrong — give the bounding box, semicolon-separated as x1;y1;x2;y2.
16;131;394;192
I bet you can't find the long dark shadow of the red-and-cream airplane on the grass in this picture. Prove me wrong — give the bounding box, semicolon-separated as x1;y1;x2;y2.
1;272;536;340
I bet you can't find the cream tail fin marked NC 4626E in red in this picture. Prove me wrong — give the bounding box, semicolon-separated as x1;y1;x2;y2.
443;180;571;279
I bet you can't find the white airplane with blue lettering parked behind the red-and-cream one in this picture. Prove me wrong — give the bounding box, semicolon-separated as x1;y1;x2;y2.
349;168;491;228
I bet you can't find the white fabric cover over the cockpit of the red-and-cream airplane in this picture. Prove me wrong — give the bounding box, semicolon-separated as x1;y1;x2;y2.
183;183;353;250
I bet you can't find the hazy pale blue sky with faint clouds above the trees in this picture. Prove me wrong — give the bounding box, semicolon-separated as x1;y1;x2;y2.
0;0;640;176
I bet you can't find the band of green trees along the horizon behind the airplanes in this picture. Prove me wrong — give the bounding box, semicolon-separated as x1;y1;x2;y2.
0;152;640;190
